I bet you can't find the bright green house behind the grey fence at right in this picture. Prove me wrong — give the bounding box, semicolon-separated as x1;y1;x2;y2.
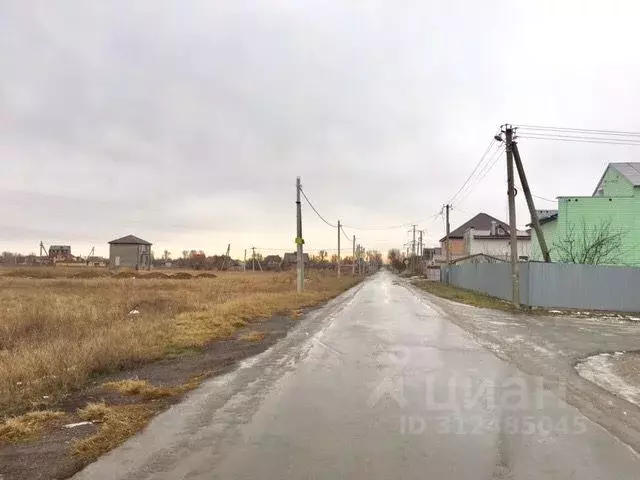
531;163;640;266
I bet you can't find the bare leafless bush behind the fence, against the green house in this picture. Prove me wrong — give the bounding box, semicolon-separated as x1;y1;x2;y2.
553;217;627;265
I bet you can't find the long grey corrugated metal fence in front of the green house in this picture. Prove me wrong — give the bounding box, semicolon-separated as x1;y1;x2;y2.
442;262;640;312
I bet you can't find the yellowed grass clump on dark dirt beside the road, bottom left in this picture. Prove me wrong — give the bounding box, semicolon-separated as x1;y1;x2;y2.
73;403;155;461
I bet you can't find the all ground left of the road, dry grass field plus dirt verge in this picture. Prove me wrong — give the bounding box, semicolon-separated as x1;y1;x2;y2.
0;270;364;480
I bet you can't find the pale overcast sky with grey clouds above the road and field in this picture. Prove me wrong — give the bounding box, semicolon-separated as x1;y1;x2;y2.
0;0;640;257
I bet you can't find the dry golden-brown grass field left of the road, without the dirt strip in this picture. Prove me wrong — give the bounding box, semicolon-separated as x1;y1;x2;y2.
0;267;358;418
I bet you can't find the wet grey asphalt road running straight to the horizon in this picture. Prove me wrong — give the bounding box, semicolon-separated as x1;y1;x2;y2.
74;272;640;480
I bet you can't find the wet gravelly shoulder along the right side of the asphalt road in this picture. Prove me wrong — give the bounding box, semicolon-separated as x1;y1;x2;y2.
401;280;640;452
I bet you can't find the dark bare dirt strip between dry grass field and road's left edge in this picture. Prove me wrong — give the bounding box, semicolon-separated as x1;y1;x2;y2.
0;317;298;480
